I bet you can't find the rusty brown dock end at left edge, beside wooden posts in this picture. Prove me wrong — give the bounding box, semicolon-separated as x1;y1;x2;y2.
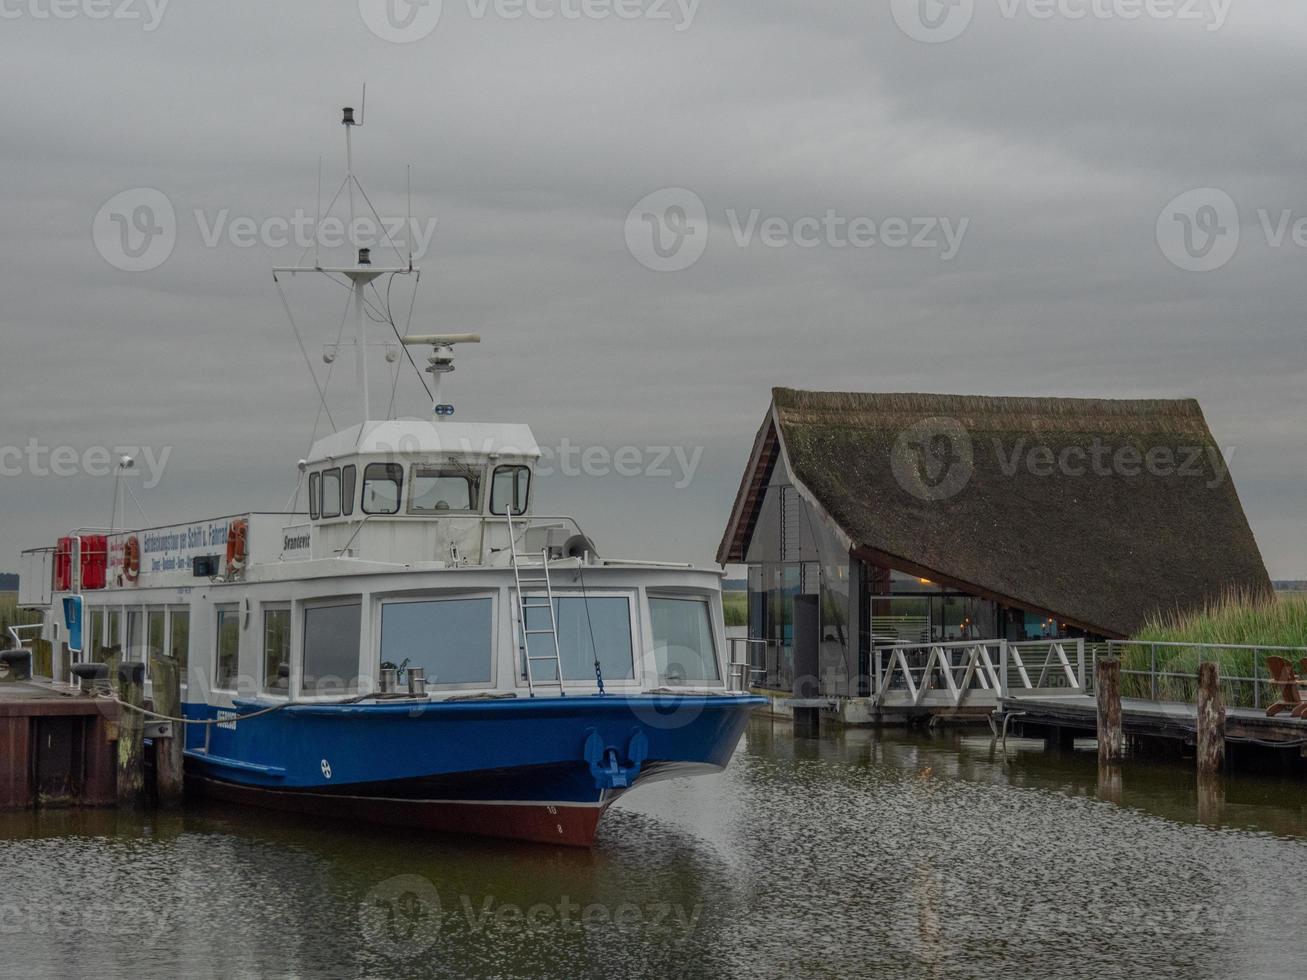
0;681;119;809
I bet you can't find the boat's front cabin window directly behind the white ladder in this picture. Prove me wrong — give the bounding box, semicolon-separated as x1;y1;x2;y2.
521;596;635;681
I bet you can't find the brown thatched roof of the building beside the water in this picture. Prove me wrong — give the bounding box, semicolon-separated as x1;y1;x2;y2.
718;388;1270;636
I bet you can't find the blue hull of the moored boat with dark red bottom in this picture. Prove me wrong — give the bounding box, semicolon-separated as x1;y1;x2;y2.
186;695;762;847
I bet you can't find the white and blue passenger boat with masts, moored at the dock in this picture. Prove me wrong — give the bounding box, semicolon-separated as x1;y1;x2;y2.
15;108;763;847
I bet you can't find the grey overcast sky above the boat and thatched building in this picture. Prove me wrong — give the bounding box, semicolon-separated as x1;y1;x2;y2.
0;0;1307;578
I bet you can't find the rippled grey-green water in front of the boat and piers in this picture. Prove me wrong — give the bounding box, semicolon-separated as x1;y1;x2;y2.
0;719;1307;980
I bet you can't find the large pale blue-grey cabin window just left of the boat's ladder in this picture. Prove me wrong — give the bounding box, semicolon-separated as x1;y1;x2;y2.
382;597;494;686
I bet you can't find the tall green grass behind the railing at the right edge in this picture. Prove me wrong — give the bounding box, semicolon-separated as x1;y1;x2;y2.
1121;593;1307;707
